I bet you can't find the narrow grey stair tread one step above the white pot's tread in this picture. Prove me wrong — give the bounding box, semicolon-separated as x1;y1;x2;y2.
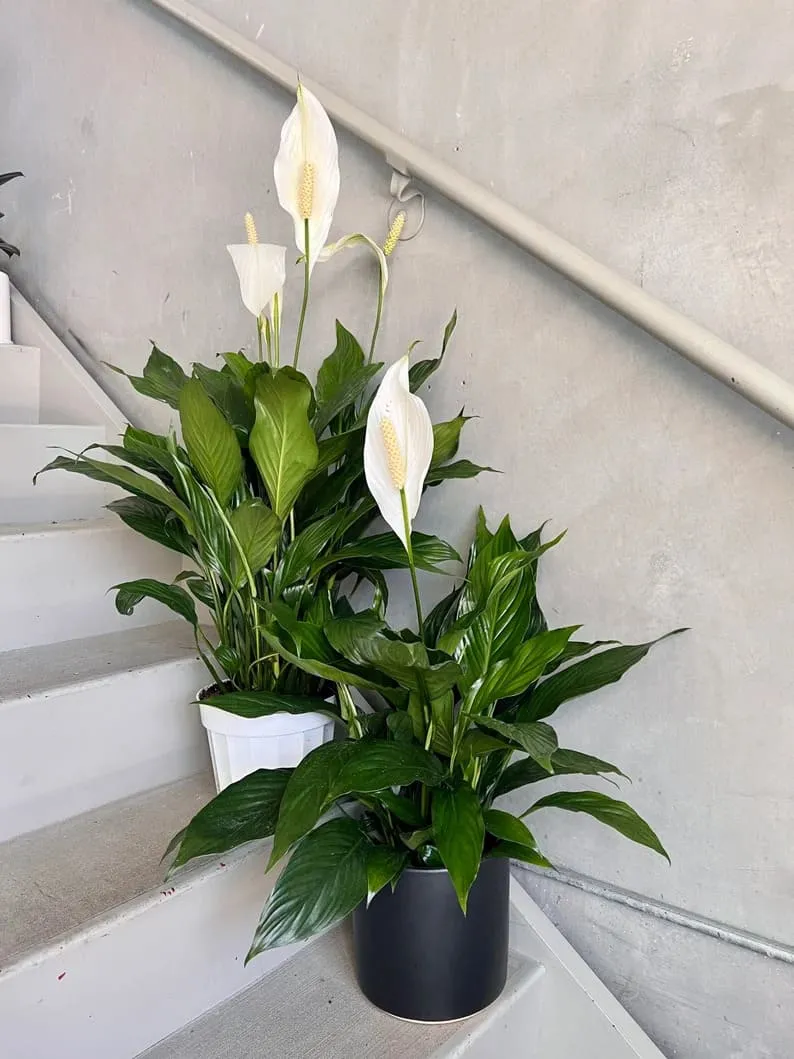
0;622;196;706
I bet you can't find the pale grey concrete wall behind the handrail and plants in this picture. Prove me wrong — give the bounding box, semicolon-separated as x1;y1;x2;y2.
0;0;794;1059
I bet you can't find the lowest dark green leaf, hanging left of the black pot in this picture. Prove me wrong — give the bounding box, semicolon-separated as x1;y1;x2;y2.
246;819;369;963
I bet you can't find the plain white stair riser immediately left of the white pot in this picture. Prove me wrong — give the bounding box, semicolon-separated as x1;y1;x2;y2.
0;660;209;841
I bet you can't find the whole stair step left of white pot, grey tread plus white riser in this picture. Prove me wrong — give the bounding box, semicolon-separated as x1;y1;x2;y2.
0;622;209;840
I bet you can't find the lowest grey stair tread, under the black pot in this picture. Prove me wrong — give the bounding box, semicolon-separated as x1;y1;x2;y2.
138;925;540;1059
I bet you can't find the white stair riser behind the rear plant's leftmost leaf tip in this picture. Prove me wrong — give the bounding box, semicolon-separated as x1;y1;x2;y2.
0;423;122;524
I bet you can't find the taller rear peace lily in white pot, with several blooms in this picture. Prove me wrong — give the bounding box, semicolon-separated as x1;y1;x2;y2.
35;89;480;789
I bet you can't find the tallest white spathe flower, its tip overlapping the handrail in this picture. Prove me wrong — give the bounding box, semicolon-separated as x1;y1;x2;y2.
273;84;339;269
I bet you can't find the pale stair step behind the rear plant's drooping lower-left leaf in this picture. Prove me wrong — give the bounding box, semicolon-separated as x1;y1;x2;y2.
0;516;181;650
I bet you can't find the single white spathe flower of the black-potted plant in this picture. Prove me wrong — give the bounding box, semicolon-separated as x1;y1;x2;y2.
364;357;433;548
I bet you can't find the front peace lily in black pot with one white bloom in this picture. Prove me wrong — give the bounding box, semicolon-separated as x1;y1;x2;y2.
170;358;679;1022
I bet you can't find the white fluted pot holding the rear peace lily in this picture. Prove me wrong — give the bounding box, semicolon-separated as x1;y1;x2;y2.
202;689;333;791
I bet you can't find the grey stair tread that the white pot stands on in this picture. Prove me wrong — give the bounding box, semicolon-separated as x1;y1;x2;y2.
0;773;215;964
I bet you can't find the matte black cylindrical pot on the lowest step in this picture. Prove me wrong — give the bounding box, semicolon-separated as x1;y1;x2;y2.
353;858;510;1022
